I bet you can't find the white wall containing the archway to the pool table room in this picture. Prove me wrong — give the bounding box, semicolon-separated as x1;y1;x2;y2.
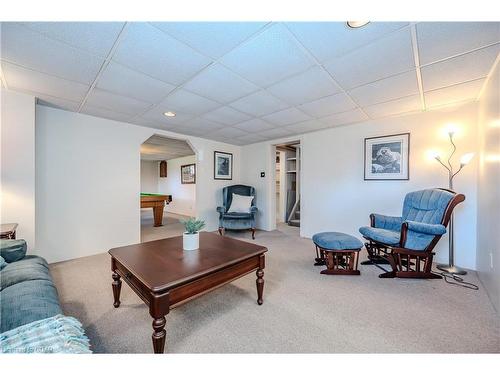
36;106;240;262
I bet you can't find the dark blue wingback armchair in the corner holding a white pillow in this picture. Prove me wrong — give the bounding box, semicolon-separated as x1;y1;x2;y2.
217;185;257;239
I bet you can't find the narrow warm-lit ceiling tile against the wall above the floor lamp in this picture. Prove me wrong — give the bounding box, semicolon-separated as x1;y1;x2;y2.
424;79;485;108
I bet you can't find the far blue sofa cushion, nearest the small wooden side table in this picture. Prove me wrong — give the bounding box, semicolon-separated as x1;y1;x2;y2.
0;255;52;290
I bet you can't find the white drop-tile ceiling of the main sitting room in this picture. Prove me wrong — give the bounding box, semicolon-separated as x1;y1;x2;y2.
0;22;500;145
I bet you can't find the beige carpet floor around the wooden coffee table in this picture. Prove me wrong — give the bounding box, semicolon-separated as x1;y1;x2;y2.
51;226;500;353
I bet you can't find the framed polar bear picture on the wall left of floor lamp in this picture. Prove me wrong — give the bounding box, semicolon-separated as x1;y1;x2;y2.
365;133;410;180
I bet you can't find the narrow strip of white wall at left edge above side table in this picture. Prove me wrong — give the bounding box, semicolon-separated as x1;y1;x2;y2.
0;90;35;250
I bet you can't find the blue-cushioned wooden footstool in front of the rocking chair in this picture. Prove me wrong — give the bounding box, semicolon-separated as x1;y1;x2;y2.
312;232;363;275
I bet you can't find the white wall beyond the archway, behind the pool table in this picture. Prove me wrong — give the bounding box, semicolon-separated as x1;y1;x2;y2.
158;155;196;216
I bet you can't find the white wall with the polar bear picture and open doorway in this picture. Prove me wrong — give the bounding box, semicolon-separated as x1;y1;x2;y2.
241;103;477;269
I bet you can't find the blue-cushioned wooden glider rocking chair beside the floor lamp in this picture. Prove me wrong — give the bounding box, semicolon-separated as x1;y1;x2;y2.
359;189;465;279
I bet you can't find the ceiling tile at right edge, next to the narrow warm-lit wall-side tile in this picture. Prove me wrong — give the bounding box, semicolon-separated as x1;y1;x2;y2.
421;44;500;91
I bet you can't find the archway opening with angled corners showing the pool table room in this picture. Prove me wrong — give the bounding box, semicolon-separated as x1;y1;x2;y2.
140;135;196;242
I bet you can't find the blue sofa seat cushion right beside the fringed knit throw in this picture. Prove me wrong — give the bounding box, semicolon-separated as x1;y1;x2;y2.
0;280;62;332
